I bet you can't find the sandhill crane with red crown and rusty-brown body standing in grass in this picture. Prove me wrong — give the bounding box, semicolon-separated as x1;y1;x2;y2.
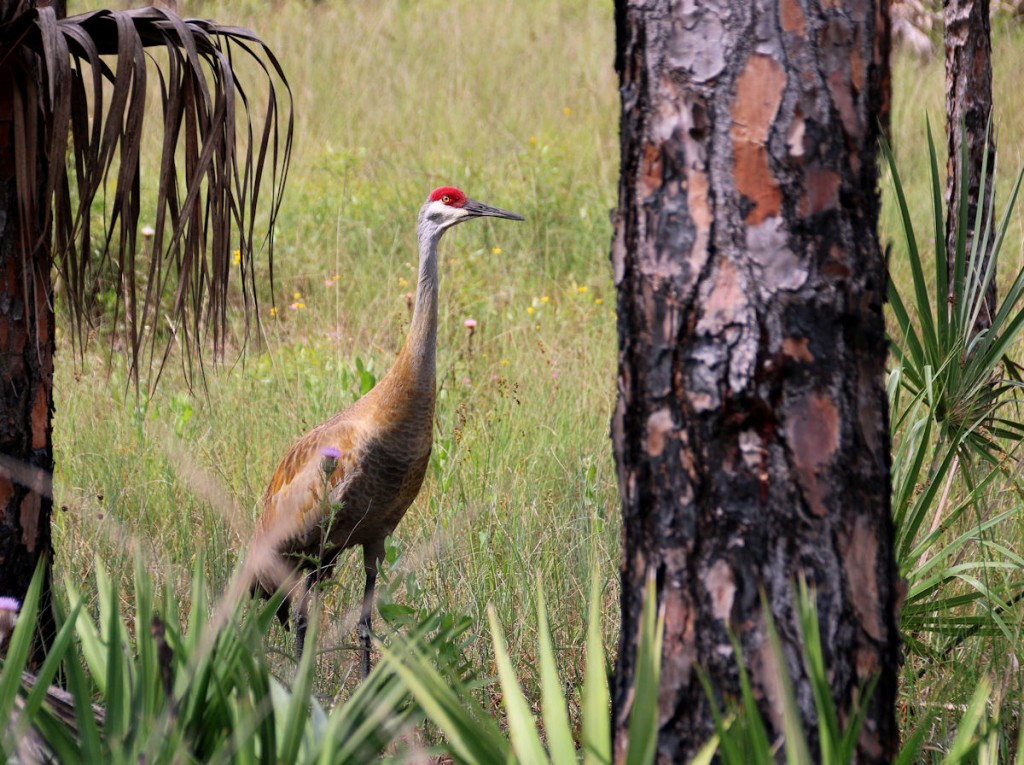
253;186;523;677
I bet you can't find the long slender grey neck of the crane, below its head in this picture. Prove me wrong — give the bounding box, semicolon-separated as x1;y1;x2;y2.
395;218;442;392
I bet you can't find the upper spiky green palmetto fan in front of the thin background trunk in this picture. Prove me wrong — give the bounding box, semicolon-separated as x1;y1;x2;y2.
882;122;1024;464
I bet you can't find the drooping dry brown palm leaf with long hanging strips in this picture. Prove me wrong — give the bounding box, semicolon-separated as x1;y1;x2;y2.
0;4;293;384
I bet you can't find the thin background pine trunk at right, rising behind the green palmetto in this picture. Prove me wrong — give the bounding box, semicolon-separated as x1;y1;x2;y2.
943;0;995;331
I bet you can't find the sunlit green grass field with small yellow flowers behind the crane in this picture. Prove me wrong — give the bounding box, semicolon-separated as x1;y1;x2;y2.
54;0;1024;753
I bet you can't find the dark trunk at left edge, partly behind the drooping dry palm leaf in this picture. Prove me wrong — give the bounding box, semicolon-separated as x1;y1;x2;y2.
0;0;62;665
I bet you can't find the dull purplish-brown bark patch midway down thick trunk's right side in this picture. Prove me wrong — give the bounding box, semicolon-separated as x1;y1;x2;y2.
785;393;840;517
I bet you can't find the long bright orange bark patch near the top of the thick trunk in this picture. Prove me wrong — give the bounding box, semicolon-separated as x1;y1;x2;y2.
729;53;785;225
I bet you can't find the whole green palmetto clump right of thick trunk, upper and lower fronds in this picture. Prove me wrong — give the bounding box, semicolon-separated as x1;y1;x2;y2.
883;126;1024;657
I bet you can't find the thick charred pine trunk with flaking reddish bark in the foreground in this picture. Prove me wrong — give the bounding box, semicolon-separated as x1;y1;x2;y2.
611;0;899;763
